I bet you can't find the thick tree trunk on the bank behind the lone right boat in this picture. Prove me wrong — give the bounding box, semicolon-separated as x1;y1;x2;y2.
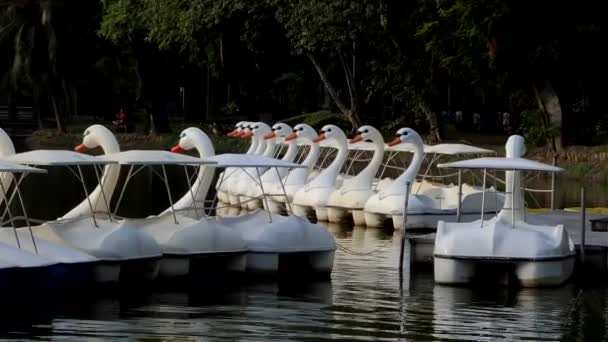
534;80;564;154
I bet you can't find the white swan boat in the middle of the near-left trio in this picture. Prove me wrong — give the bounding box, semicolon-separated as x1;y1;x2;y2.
99;150;248;278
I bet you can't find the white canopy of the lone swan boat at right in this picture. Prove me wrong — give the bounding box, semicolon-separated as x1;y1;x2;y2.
437;157;564;172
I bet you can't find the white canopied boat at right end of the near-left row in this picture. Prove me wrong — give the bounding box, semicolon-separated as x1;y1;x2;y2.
171;131;336;275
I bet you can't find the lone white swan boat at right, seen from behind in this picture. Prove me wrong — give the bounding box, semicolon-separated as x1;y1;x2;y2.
434;135;575;287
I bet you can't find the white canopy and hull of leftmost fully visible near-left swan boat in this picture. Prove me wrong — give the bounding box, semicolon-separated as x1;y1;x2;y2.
5;150;161;283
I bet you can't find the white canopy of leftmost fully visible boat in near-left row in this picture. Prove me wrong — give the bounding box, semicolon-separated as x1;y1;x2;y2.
5;150;116;166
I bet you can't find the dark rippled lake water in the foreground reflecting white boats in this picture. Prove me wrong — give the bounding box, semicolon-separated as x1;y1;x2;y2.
0;226;608;341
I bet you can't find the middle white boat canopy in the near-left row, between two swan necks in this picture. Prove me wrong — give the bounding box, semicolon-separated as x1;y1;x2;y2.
97;150;213;165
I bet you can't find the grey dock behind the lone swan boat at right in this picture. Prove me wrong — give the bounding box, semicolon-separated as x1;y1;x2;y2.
406;210;608;272
